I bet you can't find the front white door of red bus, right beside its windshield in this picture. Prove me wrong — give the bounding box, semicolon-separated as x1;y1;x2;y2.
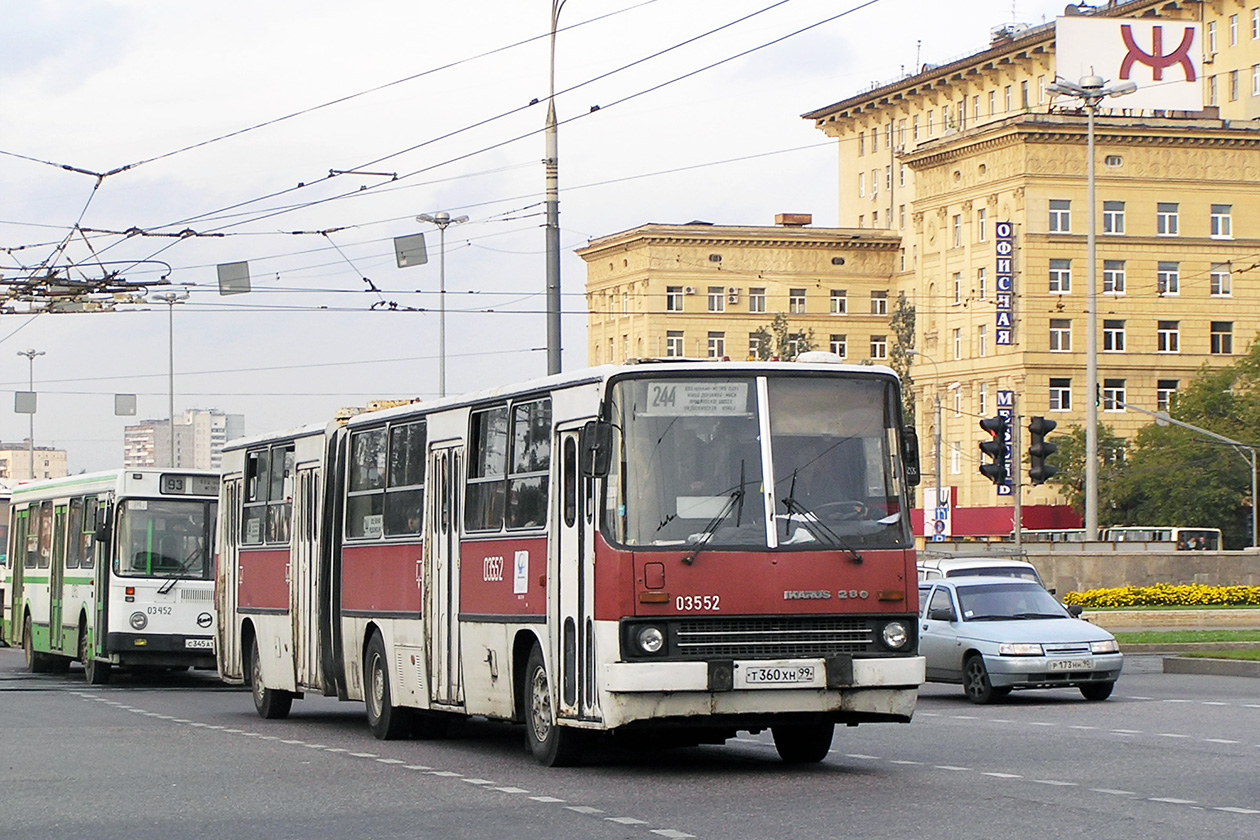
547;427;599;719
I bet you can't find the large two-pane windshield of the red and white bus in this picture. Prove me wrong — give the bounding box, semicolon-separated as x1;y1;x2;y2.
606;373;910;550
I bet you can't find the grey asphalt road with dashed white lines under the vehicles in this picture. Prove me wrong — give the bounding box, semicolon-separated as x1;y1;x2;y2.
0;650;1260;840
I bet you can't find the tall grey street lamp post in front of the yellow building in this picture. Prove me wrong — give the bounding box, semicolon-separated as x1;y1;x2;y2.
1046;76;1138;540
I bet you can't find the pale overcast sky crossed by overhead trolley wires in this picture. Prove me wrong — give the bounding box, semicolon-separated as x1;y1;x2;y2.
0;0;1063;472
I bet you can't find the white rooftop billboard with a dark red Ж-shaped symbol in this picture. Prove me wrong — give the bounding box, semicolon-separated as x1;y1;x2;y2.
1055;16;1203;111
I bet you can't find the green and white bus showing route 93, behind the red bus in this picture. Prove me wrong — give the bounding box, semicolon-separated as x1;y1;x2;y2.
3;468;219;685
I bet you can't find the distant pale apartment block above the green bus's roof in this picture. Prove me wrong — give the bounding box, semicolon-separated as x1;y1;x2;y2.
122;408;244;470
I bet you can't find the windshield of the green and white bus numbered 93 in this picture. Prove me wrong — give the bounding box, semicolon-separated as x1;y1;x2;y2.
113;499;218;581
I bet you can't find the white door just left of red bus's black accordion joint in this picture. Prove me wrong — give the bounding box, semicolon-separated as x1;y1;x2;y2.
289;463;323;688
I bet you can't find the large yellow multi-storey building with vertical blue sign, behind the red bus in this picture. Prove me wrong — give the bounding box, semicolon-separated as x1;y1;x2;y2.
580;0;1260;535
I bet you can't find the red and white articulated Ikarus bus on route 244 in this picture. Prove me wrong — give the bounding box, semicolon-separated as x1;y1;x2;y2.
217;354;924;766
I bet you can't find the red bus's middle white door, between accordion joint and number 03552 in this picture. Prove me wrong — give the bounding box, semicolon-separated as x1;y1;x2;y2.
425;443;464;705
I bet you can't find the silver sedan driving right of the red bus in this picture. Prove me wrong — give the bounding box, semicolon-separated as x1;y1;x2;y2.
919;577;1124;703
